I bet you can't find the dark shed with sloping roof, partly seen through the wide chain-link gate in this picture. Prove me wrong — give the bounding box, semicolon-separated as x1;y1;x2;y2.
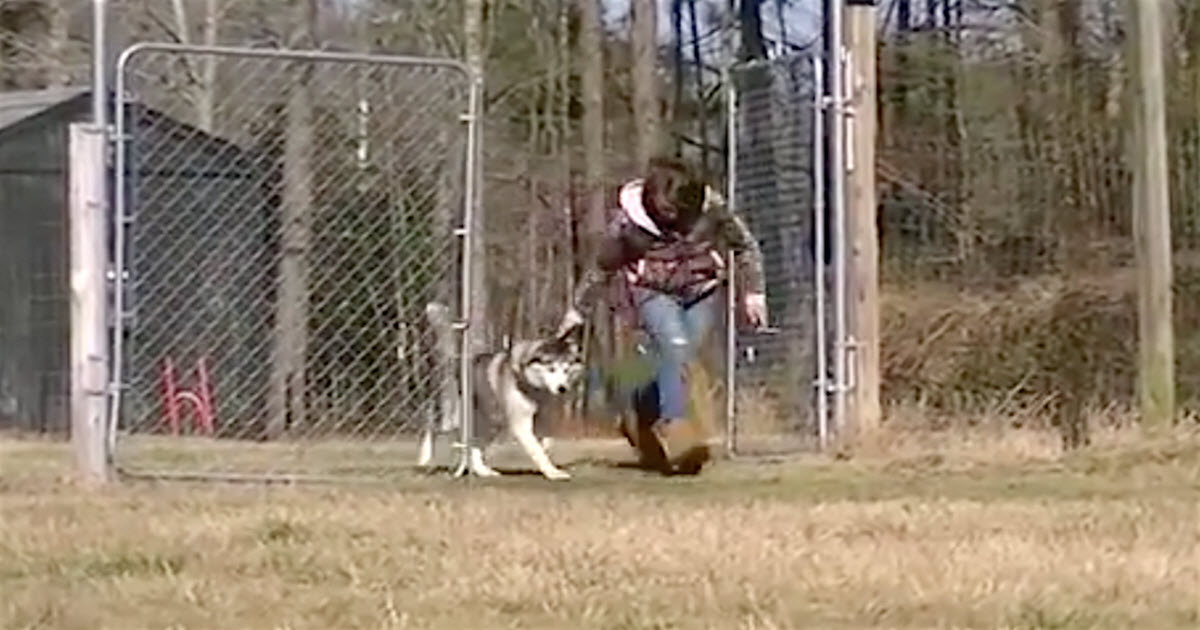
0;88;274;431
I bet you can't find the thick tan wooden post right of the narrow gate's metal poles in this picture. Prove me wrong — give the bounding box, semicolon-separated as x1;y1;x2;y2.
844;0;883;445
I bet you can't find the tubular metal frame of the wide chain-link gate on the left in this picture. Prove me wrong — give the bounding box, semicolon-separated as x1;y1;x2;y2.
101;42;484;481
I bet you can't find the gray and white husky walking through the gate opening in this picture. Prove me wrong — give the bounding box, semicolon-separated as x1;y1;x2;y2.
418;302;583;480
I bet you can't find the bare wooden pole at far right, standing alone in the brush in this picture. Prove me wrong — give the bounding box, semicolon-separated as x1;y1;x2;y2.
1128;0;1175;431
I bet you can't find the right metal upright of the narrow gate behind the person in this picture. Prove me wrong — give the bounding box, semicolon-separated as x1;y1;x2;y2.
812;55;829;450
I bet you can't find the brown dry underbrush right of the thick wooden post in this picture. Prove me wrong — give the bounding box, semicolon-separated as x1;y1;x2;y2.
881;269;1200;426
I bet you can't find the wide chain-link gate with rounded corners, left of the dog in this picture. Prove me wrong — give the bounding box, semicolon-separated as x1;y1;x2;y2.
109;43;480;479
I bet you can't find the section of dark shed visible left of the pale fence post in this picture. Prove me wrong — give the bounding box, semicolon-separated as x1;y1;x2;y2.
0;89;89;431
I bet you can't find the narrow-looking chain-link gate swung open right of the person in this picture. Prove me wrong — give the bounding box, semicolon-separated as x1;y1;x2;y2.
725;55;832;455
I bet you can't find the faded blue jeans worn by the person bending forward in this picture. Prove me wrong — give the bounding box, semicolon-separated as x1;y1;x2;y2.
632;288;720;421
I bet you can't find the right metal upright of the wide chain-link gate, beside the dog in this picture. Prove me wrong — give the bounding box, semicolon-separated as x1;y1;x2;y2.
454;70;484;476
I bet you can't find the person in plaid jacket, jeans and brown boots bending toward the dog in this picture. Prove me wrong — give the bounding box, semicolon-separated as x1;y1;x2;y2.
559;158;767;474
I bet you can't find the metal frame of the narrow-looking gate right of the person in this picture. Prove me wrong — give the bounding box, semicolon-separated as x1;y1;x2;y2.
721;52;848;458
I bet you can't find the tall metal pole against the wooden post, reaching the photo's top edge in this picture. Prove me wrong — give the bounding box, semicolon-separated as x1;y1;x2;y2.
826;0;848;441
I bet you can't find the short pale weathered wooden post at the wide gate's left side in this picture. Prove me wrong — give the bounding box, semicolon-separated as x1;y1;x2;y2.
67;124;110;482
